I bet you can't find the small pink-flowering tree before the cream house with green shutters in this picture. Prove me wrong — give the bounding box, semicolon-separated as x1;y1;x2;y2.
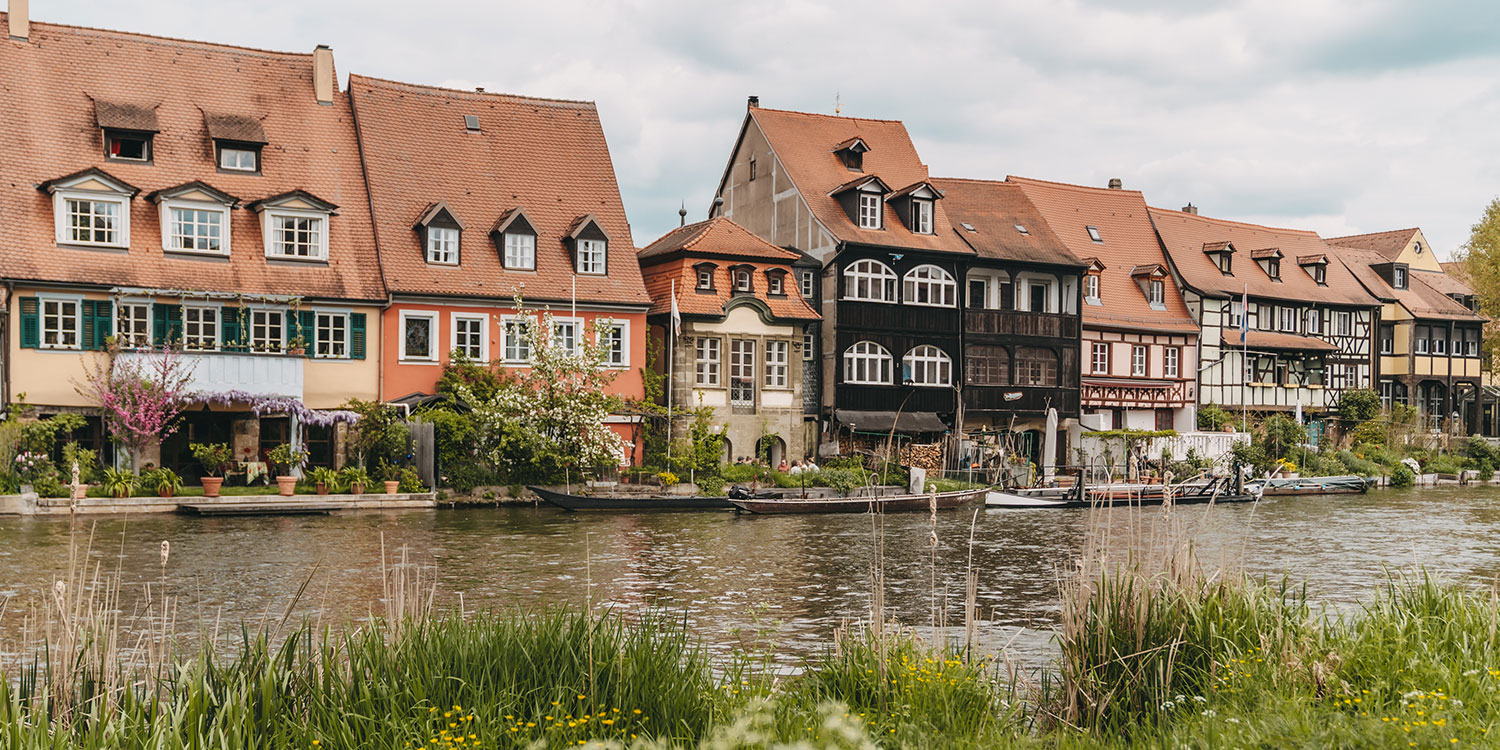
77;347;192;471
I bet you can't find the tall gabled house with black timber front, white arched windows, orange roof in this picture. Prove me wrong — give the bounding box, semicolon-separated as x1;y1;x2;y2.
713;98;974;450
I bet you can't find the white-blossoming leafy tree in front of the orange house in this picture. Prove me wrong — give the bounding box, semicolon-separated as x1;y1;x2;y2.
456;300;626;480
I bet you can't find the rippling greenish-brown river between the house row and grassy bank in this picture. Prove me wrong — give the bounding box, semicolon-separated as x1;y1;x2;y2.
0;488;1500;666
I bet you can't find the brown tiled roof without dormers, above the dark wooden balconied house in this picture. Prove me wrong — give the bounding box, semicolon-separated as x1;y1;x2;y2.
932;177;1086;267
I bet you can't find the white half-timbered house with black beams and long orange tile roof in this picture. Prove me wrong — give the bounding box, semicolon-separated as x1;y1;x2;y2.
1151;206;1379;419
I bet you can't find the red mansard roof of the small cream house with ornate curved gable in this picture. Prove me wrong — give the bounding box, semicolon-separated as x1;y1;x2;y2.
641;216;819;321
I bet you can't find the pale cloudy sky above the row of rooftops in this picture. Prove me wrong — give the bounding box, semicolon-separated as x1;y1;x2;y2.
32;0;1500;254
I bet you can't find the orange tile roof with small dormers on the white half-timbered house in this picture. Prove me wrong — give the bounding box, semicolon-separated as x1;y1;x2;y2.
1151;209;1379;308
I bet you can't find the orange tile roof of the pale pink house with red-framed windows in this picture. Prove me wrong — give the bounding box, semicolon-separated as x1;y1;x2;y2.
1005;176;1203;332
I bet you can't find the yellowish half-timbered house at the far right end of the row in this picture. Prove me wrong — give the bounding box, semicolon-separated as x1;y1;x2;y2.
1326;228;1485;435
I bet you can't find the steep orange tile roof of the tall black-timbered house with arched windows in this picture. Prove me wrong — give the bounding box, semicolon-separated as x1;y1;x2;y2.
749;108;974;254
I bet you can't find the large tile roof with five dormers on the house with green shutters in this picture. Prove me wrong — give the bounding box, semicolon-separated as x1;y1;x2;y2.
0;14;386;300
